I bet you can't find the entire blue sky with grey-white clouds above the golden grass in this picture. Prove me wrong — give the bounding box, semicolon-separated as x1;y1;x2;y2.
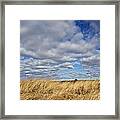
20;20;100;80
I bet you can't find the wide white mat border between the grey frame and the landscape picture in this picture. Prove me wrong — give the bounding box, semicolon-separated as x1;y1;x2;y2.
5;5;115;115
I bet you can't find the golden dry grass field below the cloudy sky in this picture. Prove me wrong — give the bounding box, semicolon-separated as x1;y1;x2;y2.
20;80;100;100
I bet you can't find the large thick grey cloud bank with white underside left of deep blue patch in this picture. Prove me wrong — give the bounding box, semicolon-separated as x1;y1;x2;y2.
21;21;99;61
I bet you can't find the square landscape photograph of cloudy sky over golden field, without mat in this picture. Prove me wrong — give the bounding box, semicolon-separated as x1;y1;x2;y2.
20;20;100;100
